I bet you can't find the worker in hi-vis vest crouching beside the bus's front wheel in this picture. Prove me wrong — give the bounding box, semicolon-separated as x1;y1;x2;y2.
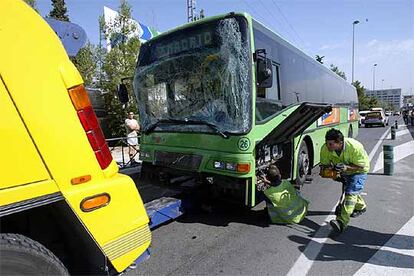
263;165;309;224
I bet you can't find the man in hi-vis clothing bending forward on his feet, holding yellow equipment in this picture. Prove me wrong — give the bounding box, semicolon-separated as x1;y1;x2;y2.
320;129;369;233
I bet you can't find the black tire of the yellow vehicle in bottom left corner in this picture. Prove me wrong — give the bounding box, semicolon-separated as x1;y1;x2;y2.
0;234;69;275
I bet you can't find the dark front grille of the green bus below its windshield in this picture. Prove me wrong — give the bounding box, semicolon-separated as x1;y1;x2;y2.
155;151;203;171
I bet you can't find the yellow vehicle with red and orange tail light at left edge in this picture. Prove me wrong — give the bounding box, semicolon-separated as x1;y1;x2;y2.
0;0;151;275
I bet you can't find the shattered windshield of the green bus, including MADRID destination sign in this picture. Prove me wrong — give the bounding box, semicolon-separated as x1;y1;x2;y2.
134;17;251;134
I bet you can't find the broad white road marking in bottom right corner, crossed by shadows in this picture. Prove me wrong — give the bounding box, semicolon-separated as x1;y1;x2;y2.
354;217;414;276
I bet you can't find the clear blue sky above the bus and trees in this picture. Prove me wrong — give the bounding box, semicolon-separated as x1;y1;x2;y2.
37;0;414;94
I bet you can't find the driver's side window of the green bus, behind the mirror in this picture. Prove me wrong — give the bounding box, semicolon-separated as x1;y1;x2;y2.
256;64;282;124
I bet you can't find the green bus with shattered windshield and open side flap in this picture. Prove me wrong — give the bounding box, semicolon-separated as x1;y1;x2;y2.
133;13;358;207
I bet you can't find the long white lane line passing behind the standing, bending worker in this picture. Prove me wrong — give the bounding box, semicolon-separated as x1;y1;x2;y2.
287;128;390;276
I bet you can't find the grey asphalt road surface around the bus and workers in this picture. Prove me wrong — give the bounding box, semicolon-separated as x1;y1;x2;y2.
123;115;414;275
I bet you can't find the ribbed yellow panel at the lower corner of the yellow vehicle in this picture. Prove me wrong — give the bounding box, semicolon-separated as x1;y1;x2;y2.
102;225;151;260
